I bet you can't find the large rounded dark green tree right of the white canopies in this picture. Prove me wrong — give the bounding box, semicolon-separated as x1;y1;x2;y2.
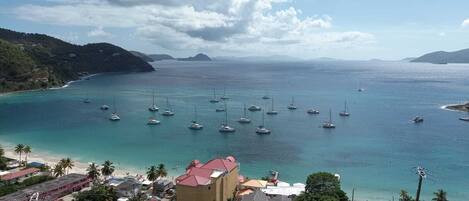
296;172;348;201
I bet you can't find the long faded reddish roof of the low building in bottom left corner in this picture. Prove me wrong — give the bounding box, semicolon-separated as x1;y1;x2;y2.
0;173;90;201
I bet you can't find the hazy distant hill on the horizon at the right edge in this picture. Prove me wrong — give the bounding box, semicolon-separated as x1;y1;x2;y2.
412;49;469;64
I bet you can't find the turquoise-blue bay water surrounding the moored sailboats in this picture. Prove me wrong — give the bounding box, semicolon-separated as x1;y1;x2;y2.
0;61;469;200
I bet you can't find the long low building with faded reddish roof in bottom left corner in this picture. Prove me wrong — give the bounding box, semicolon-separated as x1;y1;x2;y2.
0;173;91;201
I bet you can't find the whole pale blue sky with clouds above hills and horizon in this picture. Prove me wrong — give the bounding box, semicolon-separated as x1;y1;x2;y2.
0;0;469;60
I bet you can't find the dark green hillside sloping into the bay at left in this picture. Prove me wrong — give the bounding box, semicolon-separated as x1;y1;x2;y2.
0;28;154;92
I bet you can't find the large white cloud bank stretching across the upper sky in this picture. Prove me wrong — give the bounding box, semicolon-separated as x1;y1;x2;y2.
14;0;375;56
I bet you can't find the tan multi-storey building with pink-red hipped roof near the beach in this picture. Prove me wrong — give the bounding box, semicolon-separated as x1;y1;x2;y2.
176;156;239;201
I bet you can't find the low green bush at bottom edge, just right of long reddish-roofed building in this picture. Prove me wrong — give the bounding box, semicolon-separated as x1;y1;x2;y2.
73;184;117;201
